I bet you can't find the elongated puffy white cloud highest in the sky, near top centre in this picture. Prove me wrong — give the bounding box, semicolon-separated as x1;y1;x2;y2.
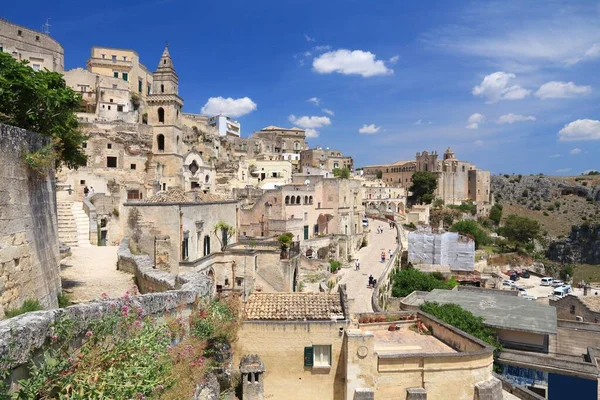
313;49;394;78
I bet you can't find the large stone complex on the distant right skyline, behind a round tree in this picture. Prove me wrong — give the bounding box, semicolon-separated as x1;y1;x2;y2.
363;148;490;204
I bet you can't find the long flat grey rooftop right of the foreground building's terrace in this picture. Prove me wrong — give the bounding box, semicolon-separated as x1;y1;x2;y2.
425;289;556;334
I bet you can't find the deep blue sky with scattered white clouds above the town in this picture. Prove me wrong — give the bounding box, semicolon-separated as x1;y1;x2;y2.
2;0;600;175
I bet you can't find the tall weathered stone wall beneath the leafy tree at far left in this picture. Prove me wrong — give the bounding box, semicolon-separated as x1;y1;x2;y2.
0;124;61;318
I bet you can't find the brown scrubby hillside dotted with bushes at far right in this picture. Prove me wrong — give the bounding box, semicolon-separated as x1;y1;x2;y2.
491;175;600;238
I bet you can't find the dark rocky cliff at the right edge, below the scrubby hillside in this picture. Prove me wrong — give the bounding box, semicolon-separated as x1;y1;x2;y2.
546;224;600;265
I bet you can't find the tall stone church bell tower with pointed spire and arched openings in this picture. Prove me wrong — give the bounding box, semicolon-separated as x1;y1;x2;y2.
147;45;183;190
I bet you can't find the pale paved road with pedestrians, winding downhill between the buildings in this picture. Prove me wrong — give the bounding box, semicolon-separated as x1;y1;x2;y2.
339;220;396;313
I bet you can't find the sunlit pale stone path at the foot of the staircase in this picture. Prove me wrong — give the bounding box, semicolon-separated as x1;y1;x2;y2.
60;246;134;303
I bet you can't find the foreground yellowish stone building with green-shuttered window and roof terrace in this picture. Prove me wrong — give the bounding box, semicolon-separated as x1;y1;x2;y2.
234;285;502;400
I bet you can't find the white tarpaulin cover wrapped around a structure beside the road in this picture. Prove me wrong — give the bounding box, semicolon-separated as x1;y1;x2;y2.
408;232;475;271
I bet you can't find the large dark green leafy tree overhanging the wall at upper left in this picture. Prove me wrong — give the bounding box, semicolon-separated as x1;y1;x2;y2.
0;53;87;169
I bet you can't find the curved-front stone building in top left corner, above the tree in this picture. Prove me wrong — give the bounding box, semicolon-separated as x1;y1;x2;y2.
0;18;65;72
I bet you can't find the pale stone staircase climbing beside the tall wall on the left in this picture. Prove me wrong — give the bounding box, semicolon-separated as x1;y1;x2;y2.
57;201;91;247
